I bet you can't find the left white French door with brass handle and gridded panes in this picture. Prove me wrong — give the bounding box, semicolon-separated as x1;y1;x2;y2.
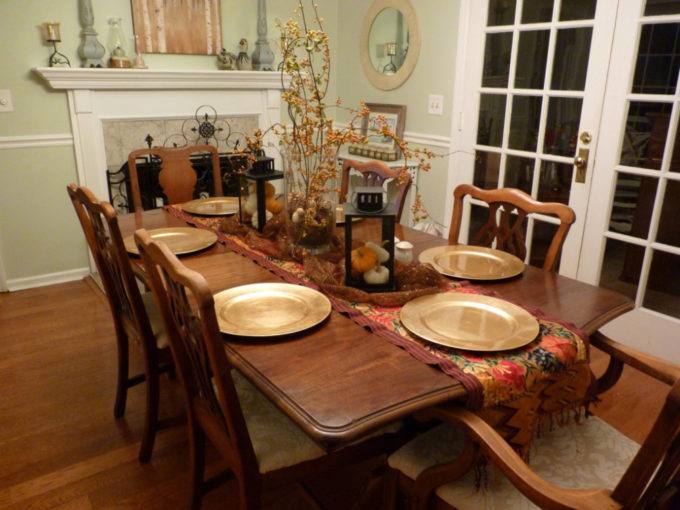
450;0;617;276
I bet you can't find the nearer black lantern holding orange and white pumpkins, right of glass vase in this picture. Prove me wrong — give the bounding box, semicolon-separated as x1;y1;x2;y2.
343;202;397;292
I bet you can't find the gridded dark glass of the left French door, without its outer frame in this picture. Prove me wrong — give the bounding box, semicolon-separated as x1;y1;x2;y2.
468;0;596;267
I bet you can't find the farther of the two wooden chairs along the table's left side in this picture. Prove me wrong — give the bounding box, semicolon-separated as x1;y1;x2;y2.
66;184;173;463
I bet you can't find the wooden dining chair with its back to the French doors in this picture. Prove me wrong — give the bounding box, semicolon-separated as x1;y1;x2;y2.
449;184;576;271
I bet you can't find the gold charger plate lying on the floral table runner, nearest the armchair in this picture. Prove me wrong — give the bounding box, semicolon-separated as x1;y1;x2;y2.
400;292;539;352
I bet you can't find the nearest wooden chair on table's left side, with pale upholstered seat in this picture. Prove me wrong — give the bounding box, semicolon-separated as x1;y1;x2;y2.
135;229;401;509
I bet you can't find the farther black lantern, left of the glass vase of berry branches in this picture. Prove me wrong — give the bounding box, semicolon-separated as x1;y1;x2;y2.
238;151;283;232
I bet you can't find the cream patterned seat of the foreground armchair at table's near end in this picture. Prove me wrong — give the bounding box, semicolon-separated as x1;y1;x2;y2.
388;416;640;510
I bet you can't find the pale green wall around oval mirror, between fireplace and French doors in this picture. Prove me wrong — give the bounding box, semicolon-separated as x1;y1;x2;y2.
337;0;460;225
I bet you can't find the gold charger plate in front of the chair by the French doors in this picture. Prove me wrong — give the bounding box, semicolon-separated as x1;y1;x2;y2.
418;244;524;280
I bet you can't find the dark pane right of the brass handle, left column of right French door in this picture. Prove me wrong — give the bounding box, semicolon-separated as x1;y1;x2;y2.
621;101;671;170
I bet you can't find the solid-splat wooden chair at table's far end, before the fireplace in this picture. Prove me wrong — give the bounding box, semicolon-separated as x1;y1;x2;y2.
128;145;224;211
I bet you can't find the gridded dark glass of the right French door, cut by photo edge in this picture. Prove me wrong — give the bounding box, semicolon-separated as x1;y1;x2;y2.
600;11;680;319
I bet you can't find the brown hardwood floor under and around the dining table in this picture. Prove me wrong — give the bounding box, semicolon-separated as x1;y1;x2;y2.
0;281;667;510
